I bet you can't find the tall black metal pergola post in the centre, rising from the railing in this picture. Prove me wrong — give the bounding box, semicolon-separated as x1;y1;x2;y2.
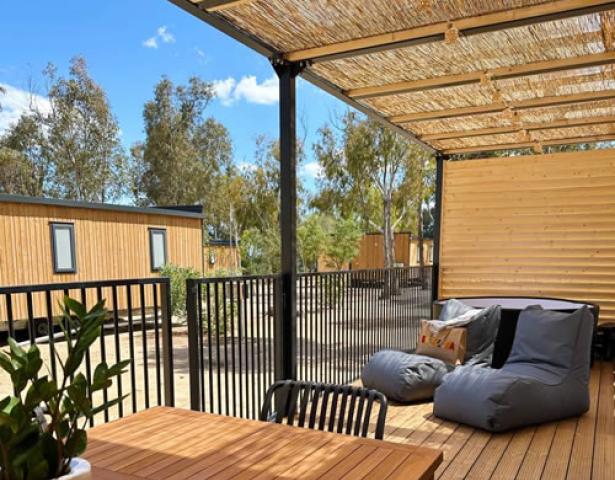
273;61;302;380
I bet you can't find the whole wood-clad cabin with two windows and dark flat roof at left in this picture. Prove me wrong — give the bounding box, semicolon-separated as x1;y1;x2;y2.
0;195;204;329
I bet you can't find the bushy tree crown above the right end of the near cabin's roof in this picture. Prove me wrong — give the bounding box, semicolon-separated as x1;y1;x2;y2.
131;77;232;210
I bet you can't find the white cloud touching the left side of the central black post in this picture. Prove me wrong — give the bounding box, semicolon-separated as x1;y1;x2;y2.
213;75;279;106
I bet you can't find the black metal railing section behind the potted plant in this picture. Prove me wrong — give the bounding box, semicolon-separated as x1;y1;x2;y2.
0;278;175;425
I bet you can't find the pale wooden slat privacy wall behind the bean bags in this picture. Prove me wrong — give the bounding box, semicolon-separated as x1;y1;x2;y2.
439;150;615;322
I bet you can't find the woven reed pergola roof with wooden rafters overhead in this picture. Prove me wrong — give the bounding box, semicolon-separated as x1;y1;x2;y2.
171;0;615;153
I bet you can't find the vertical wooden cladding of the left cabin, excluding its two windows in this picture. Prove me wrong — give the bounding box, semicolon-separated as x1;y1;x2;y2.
0;202;203;321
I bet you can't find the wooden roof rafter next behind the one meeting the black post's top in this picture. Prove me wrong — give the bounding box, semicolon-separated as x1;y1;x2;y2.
346;52;615;99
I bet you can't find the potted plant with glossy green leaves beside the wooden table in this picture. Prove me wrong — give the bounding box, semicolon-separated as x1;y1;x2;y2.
0;296;130;480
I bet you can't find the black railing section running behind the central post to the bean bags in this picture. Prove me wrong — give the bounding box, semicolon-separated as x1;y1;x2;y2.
186;267;432;418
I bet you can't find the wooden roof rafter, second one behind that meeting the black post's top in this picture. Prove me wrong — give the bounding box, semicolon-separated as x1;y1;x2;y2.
389;90;615;123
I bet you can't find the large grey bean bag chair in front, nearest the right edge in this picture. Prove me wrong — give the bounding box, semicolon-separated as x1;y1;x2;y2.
434;307;594;432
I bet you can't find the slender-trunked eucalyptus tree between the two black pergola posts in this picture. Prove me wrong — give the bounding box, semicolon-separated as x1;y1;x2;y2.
313;112;433;292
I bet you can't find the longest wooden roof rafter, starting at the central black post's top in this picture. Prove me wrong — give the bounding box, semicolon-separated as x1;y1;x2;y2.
284;0;615;62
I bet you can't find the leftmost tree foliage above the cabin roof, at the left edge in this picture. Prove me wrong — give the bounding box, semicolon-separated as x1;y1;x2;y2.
0;57;126;202
